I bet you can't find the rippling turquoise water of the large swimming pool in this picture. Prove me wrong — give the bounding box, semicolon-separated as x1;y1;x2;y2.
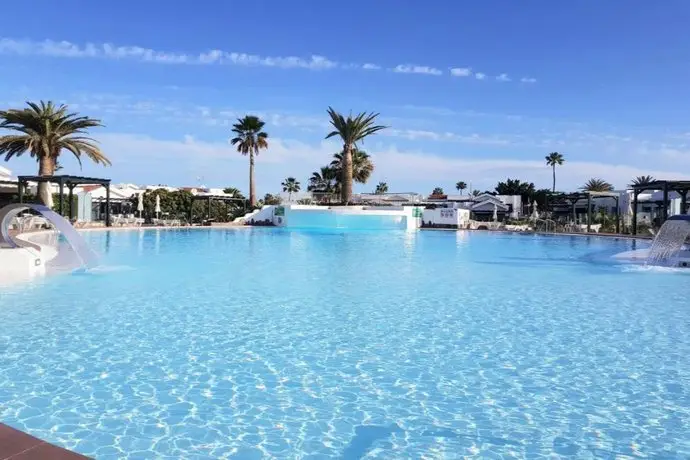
0;228;690;459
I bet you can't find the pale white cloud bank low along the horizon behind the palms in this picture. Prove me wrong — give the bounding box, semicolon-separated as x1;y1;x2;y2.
64;133;690;194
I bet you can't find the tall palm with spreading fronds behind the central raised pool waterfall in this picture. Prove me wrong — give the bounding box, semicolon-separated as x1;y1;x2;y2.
326;107;386;204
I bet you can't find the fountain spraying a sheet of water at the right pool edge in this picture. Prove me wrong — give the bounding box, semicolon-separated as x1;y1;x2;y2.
647;214;690;267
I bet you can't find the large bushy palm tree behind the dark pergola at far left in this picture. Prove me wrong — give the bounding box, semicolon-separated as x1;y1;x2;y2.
0;101;110;204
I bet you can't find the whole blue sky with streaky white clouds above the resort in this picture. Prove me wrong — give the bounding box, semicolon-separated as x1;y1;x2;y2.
0;0;690;193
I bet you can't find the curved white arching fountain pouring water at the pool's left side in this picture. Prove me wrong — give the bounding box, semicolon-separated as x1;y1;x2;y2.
0;203;98;269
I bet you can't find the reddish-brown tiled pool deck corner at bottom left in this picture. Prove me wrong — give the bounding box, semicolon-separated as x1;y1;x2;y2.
0;423;89;460
